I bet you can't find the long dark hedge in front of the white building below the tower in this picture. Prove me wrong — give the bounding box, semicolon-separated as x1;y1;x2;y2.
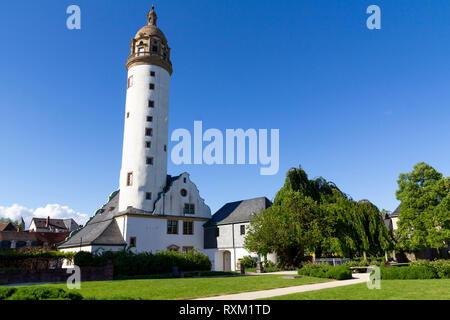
74;250;211;277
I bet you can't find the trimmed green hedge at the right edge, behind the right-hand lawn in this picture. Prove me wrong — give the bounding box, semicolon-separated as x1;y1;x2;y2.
381;260;450;280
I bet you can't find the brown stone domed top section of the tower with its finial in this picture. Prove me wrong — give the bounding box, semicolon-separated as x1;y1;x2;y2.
126;7;172;74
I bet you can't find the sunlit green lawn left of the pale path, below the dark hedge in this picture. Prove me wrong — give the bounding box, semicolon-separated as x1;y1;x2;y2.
14;275;330;300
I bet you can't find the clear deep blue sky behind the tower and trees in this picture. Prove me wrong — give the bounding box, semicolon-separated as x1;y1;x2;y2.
0;0;450;225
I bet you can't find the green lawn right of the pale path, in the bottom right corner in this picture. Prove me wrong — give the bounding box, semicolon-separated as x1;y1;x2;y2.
264;279;450;300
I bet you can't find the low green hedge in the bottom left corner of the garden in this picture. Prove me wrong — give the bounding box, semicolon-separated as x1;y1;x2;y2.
0;287;83;300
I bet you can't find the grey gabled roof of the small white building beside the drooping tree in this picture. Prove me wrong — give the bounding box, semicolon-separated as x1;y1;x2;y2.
204;197;272;227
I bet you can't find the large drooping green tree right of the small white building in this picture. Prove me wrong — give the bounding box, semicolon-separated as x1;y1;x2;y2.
245;168;392;265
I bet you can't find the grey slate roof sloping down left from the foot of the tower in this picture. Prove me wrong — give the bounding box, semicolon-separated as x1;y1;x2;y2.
58;191;126;248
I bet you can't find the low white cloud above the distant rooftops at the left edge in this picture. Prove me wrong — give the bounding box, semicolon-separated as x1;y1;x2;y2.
0;204;89;226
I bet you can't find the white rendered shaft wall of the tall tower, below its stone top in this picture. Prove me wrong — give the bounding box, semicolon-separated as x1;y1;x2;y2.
119;65;170;211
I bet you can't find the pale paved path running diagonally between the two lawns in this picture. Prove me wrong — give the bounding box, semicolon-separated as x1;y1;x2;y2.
195;273;369;300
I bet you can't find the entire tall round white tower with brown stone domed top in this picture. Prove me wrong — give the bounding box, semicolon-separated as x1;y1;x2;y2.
119;7;172;211
